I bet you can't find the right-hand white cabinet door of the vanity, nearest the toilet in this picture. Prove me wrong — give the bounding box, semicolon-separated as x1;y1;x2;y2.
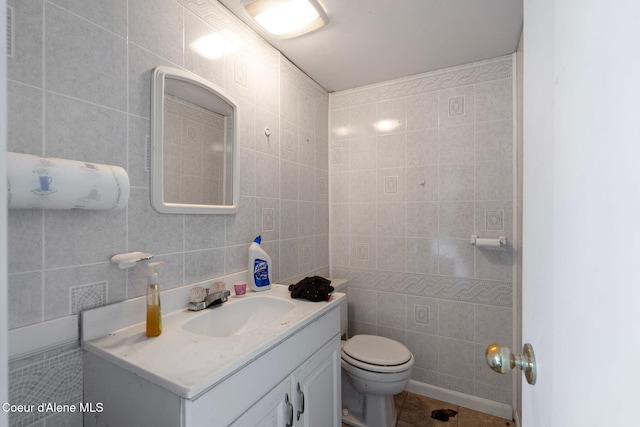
291;336;341;427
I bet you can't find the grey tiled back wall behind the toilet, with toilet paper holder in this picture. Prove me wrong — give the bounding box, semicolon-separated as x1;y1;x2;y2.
329;56;515;404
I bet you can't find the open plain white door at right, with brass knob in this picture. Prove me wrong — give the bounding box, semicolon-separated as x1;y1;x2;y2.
522;0;640;427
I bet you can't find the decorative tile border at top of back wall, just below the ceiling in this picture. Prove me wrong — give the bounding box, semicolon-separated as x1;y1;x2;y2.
331;56;512;110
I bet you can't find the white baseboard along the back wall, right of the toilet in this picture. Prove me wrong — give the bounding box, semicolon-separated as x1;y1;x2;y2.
406;380;514;420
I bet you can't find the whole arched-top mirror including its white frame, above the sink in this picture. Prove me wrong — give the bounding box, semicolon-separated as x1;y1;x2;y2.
151;67;239;214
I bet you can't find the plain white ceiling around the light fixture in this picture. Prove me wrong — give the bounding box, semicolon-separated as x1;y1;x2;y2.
220;0;522;91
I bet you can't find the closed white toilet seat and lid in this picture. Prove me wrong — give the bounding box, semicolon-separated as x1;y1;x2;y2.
342;335;413;373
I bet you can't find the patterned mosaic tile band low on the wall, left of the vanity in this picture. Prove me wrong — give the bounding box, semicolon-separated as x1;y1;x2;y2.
9;348;83;427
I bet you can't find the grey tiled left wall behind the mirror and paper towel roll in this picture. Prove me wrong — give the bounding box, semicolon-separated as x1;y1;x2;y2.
8;0;329;425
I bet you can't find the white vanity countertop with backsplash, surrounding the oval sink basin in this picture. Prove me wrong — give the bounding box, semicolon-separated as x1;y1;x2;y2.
82;280;345;399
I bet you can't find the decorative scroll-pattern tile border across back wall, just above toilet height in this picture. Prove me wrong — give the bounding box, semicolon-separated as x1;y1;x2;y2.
331;267;513;308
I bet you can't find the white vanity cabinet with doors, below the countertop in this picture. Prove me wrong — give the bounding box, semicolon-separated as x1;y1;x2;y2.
84;305;341;427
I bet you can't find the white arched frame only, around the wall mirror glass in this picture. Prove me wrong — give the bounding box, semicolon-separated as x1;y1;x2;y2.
149;66;240;214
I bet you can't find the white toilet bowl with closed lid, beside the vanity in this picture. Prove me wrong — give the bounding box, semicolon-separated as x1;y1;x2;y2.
341;335;414;427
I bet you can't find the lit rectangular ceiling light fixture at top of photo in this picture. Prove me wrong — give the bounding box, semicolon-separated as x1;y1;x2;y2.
242;0;329;39
